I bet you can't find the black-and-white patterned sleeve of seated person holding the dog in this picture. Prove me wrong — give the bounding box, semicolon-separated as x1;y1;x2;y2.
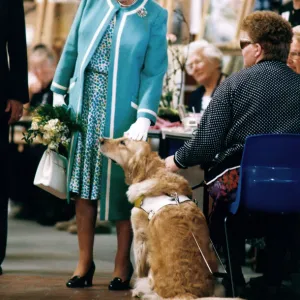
174;80;233;168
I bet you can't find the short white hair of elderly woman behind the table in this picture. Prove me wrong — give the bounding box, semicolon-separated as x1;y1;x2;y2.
184;40;223;67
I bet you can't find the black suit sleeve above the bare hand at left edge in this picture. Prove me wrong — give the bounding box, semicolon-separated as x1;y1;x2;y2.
7;0;29;103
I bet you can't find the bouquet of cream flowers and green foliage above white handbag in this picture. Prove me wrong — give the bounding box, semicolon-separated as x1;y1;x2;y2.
23;104;81;152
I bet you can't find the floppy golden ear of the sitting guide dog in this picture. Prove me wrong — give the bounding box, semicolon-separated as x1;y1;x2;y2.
125;143;151;184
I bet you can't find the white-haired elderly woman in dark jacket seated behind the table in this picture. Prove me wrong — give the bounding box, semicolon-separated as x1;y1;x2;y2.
185;40;226;113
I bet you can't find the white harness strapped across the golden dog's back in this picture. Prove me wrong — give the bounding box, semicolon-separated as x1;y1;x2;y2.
134;195;192;220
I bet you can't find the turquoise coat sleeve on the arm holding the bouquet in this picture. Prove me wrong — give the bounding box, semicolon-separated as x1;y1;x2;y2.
51;0;87;95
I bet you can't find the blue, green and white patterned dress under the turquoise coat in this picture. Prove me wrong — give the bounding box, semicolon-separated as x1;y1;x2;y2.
70;19;115;200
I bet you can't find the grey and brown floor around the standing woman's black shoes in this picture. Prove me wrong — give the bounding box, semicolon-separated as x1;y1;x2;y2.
0;213;253;300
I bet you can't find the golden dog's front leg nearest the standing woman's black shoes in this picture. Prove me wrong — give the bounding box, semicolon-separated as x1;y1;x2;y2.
131;207;149;278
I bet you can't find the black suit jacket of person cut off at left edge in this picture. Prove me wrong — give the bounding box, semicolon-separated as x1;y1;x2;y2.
0;0;29;114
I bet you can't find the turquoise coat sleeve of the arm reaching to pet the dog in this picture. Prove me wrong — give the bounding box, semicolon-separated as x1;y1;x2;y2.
137;9;168;124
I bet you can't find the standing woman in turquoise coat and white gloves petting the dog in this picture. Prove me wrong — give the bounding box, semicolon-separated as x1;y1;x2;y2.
51;0;167;290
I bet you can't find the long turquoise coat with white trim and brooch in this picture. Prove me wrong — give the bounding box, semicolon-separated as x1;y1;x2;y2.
51;0;168;220
